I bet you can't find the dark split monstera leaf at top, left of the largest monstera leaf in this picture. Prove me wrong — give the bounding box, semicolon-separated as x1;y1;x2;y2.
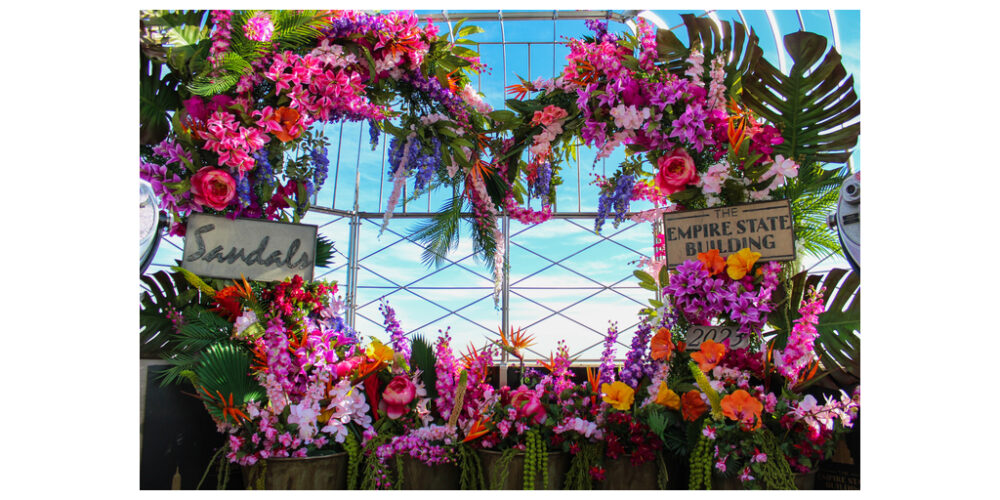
656;14;763;89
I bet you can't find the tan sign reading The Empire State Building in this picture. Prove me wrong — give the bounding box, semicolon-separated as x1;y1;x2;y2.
663;200;795;269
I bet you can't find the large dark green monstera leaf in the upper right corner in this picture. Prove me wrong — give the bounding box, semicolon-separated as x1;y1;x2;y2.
743;31;861;165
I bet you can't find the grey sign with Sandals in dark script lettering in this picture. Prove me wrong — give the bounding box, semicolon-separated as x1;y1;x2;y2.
181;214;317;281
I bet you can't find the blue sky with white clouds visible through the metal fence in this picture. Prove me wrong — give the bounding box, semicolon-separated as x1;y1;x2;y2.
146;10;861;360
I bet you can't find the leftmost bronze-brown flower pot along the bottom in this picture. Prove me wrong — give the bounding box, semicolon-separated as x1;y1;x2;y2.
243;453;347;490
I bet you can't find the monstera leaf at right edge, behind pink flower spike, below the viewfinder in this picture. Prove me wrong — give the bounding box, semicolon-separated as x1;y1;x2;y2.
768;269;861;385
